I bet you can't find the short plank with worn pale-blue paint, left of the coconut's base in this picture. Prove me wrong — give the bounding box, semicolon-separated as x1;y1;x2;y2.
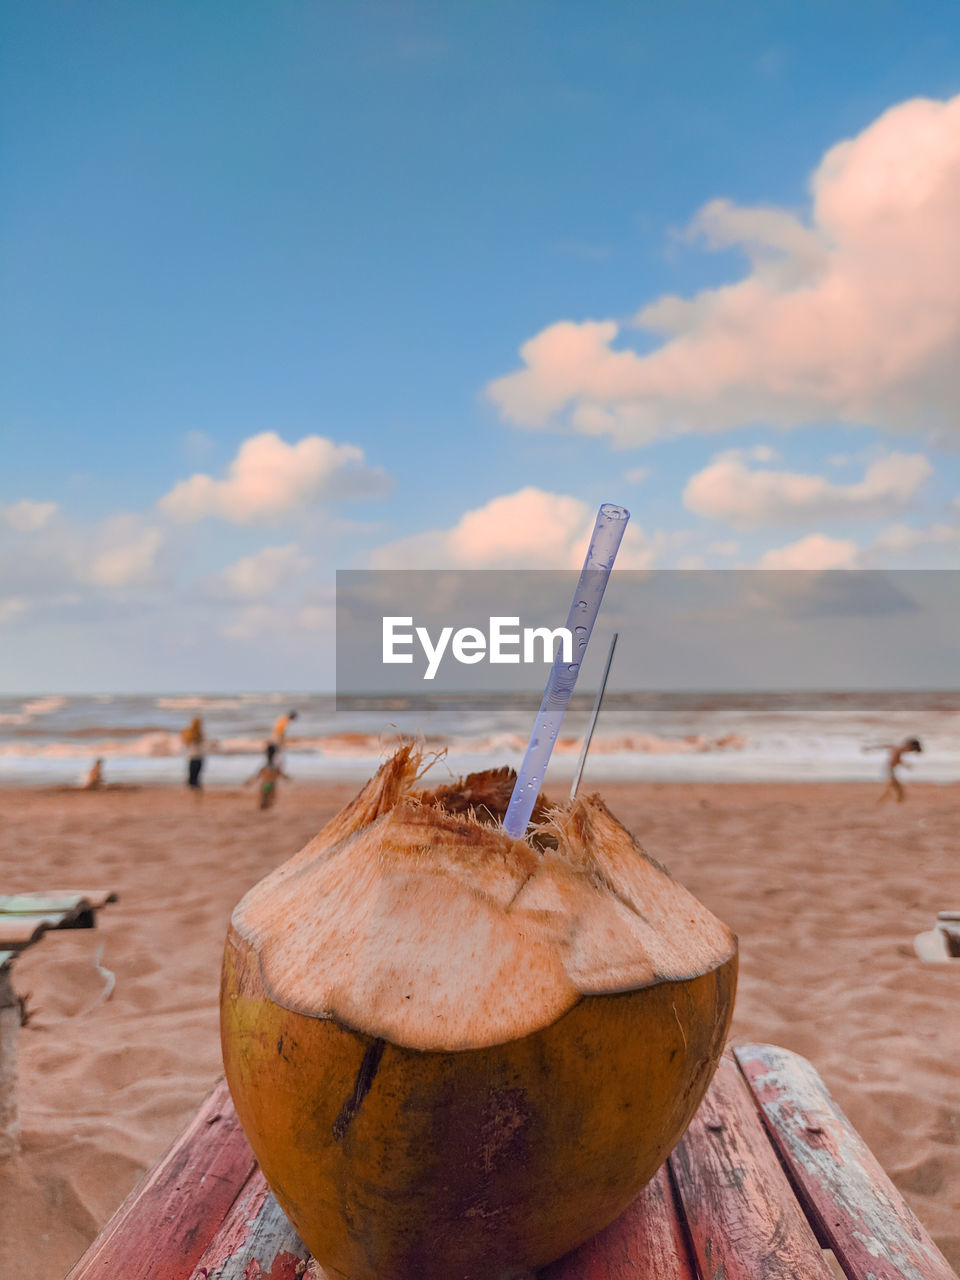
186;1169;310;1280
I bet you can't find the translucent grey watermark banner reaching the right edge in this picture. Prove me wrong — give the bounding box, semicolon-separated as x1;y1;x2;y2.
337;570;960;709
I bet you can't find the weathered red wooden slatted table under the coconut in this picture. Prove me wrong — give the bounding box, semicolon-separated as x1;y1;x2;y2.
68;1044;956;1280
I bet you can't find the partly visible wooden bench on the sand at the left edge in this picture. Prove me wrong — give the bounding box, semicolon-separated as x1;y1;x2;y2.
0;890;116;1158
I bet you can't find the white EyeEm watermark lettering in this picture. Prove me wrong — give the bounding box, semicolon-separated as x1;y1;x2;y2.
383;616;573;680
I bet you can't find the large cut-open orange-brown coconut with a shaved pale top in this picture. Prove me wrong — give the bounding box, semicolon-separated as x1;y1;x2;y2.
221;748;736;1280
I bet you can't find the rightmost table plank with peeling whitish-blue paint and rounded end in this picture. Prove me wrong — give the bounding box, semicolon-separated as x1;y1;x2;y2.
735;1044;956;1280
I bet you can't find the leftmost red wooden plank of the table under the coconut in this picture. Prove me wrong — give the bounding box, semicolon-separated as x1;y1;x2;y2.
68;1080;256;1280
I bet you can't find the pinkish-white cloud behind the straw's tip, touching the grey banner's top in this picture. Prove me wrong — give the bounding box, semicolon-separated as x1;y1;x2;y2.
370;488;675;568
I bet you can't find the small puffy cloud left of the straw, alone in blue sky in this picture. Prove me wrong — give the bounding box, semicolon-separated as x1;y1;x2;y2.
157;431;388;525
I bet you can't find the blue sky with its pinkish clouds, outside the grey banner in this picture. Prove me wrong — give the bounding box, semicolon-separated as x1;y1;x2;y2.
0;0;960;690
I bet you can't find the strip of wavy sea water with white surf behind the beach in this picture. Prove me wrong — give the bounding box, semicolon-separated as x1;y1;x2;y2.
0;690;960;787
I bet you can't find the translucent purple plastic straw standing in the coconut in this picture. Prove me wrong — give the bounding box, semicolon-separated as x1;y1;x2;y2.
503;502;630;840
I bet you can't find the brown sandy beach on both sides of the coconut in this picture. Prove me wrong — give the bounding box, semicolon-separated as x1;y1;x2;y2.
0;783;960;1280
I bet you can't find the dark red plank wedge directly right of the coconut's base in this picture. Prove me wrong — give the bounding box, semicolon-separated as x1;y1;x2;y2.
538;1165;696;1280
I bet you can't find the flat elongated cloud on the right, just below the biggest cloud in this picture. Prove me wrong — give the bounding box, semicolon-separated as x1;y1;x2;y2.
684;449;933;529
